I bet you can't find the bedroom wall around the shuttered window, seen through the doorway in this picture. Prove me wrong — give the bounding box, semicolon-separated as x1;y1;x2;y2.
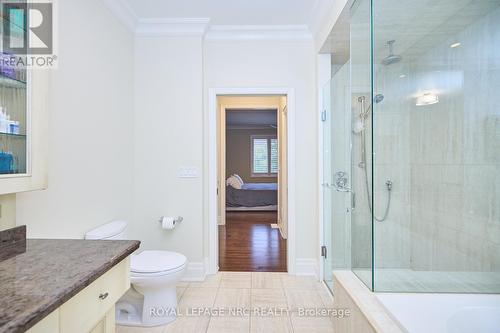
226;129;278;183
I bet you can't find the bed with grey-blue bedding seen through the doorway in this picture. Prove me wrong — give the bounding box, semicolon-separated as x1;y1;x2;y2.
226;183;278;211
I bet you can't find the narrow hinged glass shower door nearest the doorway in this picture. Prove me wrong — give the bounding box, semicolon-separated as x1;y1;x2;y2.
322;67;351;289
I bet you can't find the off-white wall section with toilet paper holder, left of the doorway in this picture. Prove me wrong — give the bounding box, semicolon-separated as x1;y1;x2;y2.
130;36;204;272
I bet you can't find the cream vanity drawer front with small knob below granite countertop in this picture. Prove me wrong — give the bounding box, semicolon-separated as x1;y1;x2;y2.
59;258;130;333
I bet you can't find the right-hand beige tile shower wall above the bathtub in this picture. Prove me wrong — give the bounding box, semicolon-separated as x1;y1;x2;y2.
409;10;500;271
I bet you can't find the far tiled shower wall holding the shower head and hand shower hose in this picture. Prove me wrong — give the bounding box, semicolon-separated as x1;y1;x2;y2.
351;2;411;269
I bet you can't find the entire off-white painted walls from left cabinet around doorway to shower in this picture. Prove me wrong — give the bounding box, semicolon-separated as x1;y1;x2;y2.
17;4;318;273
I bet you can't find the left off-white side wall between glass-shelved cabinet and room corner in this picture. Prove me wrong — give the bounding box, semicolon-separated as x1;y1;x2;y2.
17;0;133;238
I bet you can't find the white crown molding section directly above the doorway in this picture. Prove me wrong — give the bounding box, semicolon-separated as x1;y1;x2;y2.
205;25;312;40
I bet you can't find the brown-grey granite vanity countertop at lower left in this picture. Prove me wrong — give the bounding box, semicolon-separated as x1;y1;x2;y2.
0;239;140;332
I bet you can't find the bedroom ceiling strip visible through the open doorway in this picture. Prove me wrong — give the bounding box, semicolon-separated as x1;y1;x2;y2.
226;109;277;128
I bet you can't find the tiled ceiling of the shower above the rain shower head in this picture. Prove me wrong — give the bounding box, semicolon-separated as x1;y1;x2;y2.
321;0;500;65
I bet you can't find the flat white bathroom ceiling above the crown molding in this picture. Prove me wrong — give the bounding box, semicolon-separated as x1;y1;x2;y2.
123;0;324;25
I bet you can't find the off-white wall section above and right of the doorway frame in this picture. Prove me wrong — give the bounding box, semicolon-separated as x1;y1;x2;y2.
204;40;318;262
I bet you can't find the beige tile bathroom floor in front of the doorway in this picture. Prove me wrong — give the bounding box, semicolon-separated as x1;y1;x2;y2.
116;272;334;333
